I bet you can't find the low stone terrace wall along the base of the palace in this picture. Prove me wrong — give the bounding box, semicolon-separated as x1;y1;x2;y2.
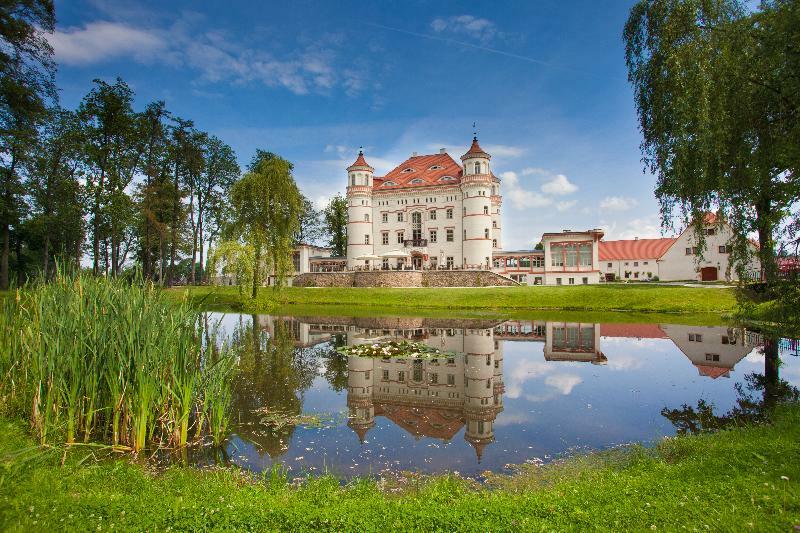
293;270;518;287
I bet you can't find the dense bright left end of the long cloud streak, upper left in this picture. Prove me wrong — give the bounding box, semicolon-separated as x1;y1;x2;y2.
47;21;168;65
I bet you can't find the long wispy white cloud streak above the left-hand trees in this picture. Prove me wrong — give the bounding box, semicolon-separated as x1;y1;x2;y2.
48;17;367;96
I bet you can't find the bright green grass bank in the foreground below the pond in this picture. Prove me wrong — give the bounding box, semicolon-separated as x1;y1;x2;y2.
0;404;800;531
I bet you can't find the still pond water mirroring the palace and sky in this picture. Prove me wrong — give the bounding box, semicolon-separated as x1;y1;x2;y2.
199;313;800;477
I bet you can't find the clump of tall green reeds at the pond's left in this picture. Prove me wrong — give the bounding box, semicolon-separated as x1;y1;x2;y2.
0;272;236;452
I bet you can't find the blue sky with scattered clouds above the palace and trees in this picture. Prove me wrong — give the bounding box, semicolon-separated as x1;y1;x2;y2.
52;0;660;249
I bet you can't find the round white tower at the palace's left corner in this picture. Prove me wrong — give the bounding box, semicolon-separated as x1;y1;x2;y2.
347;150;375;268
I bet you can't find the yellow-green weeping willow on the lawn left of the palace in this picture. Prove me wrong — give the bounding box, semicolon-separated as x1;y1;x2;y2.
231;150;303;298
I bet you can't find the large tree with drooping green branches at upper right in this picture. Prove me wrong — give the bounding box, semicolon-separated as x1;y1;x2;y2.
624;0;800;284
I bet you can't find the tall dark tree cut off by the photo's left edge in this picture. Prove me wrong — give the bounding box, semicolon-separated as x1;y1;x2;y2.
0;0;57;290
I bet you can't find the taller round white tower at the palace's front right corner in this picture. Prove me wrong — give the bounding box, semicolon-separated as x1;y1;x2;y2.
461;135;490;268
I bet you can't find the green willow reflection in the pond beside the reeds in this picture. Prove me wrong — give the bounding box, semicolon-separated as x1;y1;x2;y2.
232;315;317;457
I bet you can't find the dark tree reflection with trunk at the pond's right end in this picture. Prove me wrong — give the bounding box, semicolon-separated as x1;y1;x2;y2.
661;338;800;434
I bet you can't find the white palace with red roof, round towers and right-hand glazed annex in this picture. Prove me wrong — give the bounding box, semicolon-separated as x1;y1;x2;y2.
347;136;603;285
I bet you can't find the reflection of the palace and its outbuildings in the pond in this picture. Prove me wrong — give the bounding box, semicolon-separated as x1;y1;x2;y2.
250;317;755;460
